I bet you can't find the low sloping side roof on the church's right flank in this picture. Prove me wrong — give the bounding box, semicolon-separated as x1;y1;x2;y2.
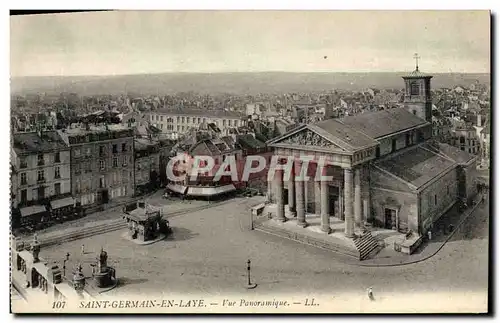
375;146;455;188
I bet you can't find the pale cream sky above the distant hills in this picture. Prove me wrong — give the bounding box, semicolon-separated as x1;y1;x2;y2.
10;11;490;77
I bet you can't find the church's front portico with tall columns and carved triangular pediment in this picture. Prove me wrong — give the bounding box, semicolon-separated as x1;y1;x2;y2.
264;123;376;238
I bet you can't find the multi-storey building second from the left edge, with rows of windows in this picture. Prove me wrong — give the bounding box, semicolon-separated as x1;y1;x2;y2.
61;124;134;207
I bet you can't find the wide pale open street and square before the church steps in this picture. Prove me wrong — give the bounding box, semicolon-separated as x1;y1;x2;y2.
41;198;488;312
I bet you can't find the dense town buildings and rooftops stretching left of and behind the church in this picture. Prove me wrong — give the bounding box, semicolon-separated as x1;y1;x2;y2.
11;71;490;230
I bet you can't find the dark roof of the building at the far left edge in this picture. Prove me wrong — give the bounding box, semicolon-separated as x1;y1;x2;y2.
13;131;69;153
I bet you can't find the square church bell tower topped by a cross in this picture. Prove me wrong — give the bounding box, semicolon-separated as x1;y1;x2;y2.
403;54;432;122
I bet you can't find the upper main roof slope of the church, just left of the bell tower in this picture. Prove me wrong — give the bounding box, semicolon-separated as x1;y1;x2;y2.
339;108;428;139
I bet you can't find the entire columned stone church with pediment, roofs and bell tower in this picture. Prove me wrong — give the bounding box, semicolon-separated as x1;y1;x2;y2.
268;63;476;242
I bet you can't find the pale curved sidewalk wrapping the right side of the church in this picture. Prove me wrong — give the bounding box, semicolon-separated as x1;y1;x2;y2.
348;197;489;267
